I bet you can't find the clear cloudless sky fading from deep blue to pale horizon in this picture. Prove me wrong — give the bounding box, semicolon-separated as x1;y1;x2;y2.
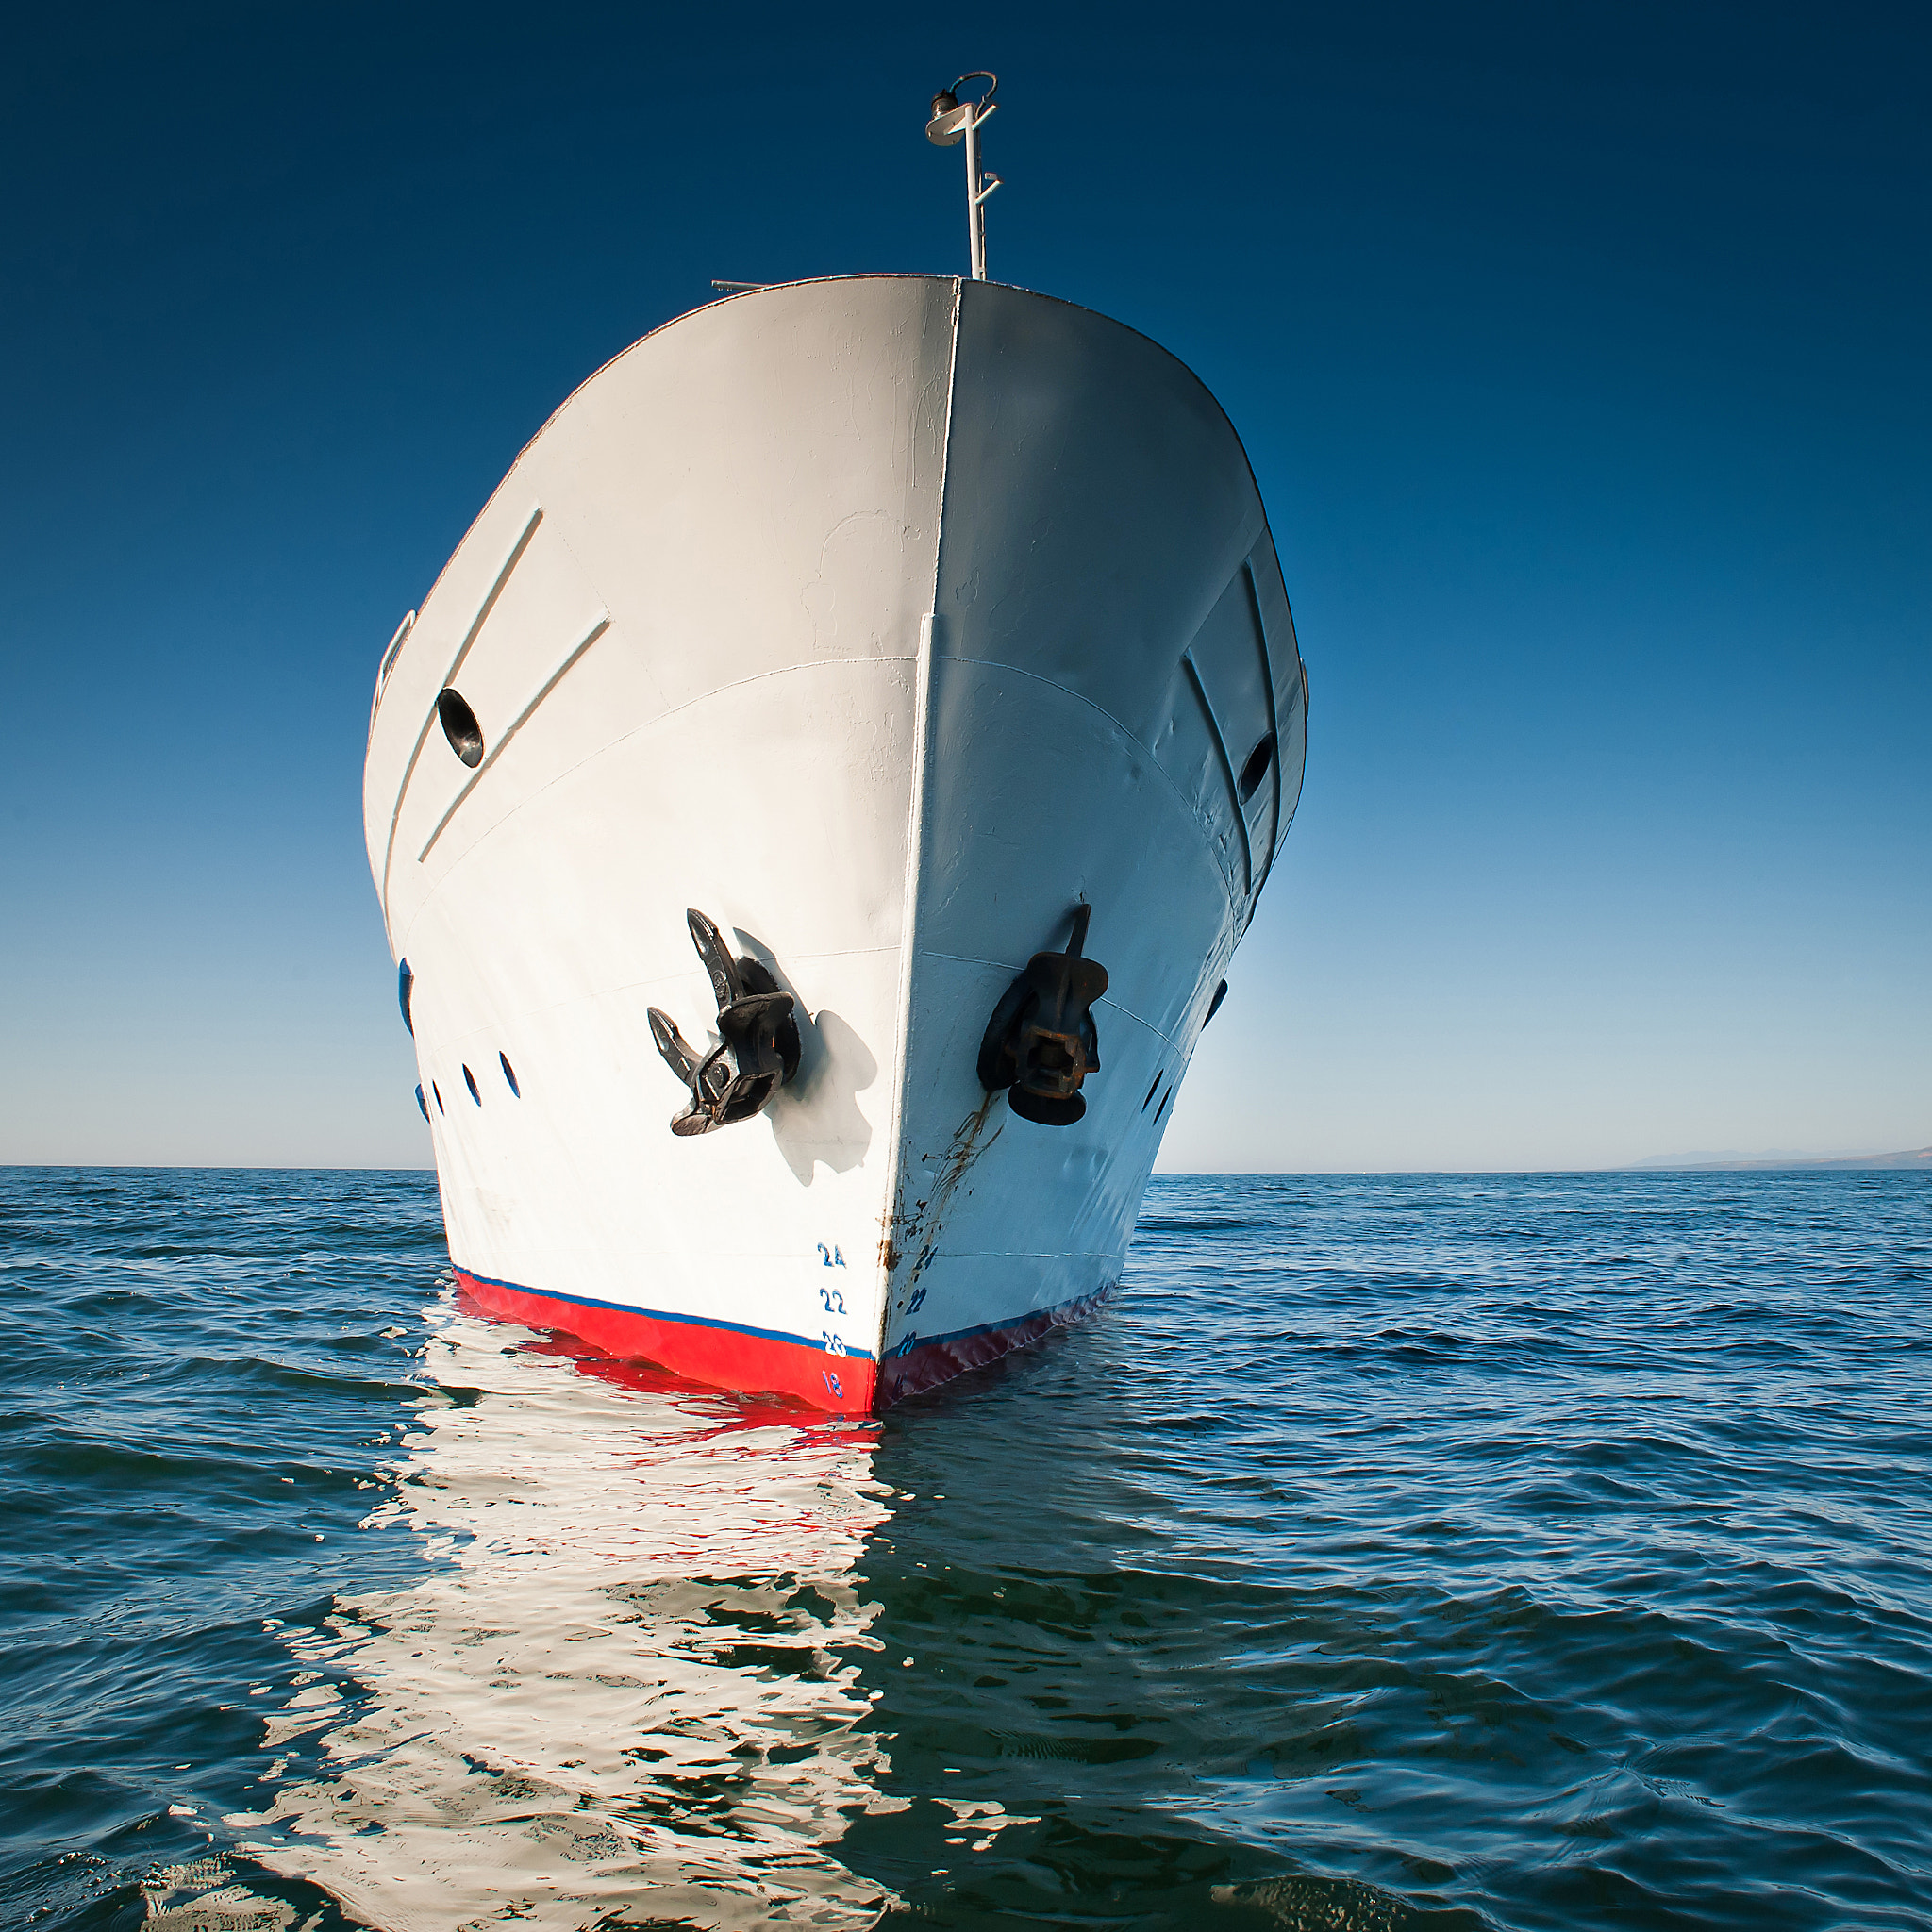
0;0;1932;1169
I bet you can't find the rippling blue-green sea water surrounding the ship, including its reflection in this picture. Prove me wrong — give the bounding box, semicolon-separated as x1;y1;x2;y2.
0;1169;1932;1932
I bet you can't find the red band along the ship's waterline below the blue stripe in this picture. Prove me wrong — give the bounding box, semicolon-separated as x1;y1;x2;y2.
456;1267;1113;1414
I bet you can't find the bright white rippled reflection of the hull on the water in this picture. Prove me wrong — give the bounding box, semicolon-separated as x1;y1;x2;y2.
245;1306;904;1932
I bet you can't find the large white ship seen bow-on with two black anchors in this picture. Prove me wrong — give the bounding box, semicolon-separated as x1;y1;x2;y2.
363;83;1307;1414
